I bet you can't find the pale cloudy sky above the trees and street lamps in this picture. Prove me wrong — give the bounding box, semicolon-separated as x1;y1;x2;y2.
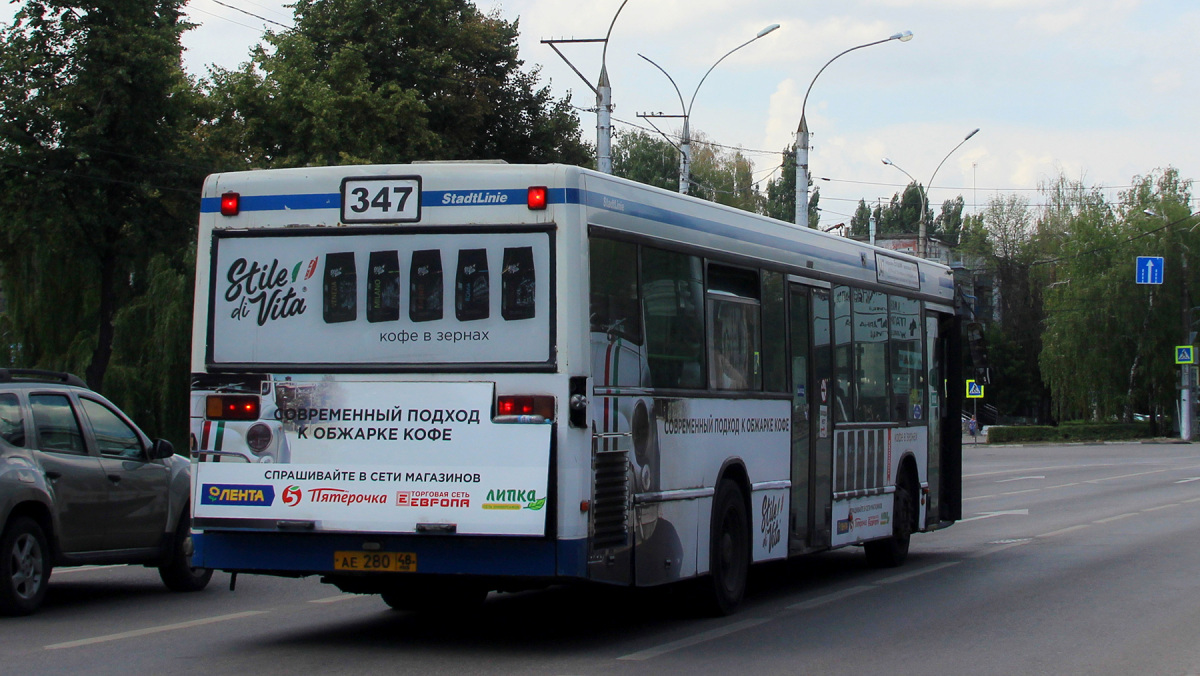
0;0;1200;227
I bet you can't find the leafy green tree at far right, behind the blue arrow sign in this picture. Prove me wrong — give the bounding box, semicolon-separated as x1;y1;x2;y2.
1042;168;1200;420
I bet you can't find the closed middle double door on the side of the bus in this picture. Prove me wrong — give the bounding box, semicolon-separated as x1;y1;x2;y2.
788;283;833;554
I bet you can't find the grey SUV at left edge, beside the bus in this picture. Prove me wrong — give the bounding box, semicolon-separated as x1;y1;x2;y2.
0;369;212;615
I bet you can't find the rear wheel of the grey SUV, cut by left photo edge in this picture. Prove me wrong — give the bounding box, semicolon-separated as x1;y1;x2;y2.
0;516;50;615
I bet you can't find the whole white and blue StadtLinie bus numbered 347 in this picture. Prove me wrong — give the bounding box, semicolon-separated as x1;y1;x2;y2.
192;162;962;612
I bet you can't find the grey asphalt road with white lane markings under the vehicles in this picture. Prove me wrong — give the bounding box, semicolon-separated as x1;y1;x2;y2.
0;443;1200;676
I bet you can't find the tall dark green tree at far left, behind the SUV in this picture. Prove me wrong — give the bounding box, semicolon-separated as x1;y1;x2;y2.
0;0;204;439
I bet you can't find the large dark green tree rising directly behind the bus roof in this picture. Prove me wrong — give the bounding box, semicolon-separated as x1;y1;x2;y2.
205;0;592;168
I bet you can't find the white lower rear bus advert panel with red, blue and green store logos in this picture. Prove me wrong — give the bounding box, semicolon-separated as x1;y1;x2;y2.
192;384;552;536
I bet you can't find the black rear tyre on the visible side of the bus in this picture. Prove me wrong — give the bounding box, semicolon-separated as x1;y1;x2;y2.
704;479;750;616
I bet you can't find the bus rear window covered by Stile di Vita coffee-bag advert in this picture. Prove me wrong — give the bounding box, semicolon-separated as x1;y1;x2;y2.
208;232;553;370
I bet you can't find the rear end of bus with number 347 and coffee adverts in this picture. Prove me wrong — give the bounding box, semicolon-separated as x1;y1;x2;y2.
192;164;587;606
